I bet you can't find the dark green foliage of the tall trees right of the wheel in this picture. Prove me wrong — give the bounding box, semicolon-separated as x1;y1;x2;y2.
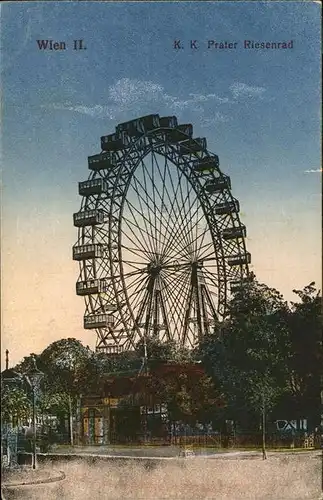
200;280;322;428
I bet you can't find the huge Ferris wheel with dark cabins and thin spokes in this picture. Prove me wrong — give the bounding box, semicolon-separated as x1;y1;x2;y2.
73;115;251;353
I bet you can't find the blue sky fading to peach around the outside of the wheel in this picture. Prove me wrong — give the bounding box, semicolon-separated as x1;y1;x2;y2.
1;2;321;366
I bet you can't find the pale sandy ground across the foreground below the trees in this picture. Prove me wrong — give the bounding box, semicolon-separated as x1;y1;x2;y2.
1;448;322;500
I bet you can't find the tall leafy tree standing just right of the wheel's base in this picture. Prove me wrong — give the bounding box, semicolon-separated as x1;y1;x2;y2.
200;280;290;428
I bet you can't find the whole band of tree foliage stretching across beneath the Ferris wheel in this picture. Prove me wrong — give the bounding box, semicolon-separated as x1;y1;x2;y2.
2;280;323;432
